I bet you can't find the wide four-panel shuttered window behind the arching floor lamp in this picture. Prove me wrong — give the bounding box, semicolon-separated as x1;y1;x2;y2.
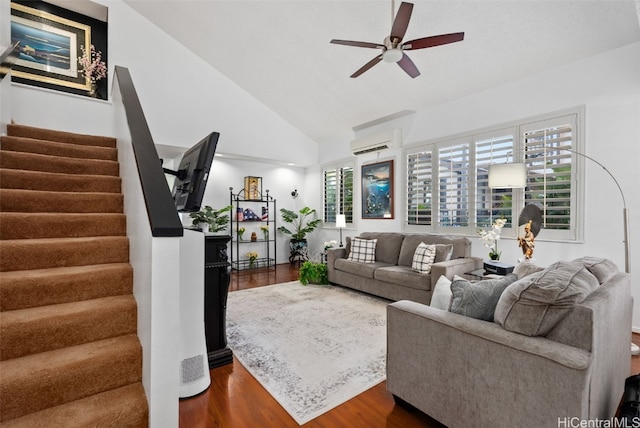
404;111;581;240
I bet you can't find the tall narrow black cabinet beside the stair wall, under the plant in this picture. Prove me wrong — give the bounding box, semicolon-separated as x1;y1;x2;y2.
204;235;233;368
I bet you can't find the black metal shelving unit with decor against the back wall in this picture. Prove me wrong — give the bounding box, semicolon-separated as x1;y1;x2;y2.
229;187;277;270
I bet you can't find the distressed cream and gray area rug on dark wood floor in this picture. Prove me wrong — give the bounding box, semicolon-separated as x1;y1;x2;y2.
227;281;389;425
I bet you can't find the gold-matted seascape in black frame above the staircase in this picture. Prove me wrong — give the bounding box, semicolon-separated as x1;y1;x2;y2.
11;1;108;99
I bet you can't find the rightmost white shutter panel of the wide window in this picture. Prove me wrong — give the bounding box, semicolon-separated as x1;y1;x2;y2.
523;115;576;239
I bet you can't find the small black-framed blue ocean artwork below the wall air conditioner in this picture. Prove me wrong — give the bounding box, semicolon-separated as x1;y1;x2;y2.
362;160;394;219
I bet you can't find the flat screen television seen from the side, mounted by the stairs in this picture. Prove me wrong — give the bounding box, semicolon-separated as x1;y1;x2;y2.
164;132;220;212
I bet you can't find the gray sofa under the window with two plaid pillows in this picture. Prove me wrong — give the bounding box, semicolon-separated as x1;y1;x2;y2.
327;232;483;304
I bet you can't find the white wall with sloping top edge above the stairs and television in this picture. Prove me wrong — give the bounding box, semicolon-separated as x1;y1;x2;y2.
7;0;317;165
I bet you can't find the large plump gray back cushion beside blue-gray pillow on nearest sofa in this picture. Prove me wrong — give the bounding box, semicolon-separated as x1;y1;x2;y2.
495;262;599;336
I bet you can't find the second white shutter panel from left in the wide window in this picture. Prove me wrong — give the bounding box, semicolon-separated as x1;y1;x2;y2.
438;143;470;227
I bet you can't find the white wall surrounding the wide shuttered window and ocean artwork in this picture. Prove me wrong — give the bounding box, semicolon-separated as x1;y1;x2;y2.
307;43;640;331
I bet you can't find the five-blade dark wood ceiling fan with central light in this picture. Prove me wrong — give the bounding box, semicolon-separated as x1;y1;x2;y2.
331;2;464;78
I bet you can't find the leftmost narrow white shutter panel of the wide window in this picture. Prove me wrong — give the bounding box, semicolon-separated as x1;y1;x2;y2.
407;151;433;225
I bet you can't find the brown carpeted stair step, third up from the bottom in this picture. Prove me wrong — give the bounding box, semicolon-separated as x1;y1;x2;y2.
0;294;137;361
